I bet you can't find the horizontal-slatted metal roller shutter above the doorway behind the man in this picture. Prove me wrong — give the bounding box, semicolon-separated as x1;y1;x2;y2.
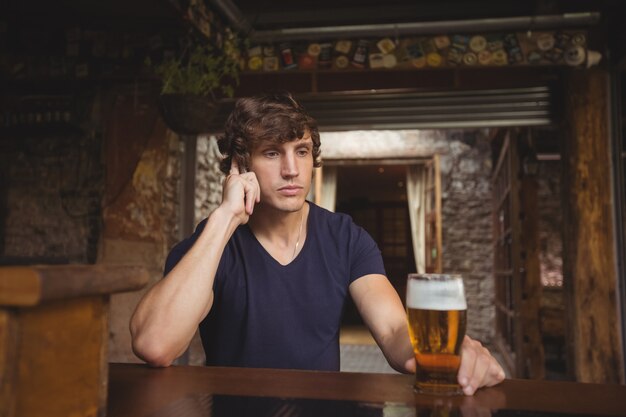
205;86;555;132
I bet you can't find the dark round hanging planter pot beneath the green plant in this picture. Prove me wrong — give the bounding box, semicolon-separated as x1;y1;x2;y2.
159;94;219;135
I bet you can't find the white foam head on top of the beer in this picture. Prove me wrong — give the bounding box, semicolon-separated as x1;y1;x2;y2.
406;274;467;311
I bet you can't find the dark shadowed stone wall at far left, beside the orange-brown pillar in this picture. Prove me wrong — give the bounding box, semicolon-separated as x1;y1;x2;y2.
0;105;104;264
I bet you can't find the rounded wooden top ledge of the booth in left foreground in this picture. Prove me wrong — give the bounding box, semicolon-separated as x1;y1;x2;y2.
0;265;149;306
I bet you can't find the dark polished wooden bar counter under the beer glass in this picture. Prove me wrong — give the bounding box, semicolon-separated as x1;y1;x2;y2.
108;364;626;417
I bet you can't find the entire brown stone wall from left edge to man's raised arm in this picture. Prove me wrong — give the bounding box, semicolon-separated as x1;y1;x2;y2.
0;84;181;362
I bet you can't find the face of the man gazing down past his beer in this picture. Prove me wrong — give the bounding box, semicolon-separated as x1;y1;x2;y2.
250;132;313;212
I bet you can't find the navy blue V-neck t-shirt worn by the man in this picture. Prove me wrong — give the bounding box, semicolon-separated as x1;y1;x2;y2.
165;202;385;371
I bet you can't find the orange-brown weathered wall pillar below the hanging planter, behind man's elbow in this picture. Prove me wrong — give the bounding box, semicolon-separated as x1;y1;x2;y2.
98;85;182;362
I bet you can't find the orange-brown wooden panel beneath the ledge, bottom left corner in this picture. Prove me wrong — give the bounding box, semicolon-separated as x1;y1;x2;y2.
0;295;109;417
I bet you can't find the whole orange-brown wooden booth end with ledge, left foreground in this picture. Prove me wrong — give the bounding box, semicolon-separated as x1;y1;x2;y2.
0;265;148;417
